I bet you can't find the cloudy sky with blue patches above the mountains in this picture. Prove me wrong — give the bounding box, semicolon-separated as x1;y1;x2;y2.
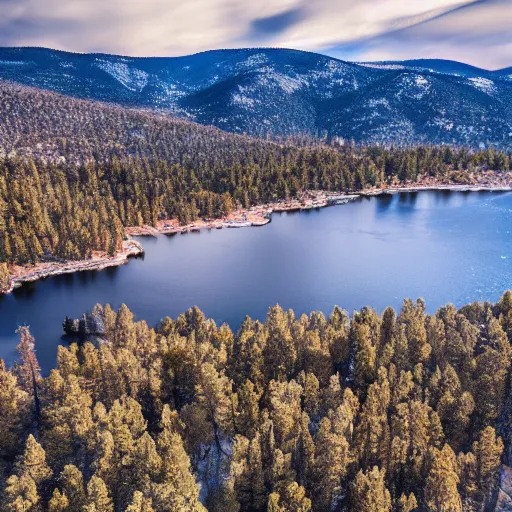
0;0;512;69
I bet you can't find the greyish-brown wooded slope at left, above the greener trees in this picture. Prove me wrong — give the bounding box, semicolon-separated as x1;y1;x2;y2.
0;80;288;166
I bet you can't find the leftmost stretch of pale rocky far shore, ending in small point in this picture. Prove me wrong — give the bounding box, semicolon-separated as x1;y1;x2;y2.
3;239;144;294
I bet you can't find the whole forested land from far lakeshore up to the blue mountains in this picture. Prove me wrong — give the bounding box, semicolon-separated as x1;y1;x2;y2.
0;83;511;272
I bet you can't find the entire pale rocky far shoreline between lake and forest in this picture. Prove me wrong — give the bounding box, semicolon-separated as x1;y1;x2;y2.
0;181;512;294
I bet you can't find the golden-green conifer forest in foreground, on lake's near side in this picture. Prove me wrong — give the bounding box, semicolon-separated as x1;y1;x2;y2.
0;292;512;512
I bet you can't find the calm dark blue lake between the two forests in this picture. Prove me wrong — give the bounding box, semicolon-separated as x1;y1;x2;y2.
0;191;512;372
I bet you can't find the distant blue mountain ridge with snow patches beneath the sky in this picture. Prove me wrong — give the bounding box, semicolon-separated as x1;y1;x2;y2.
0;48;512;149
